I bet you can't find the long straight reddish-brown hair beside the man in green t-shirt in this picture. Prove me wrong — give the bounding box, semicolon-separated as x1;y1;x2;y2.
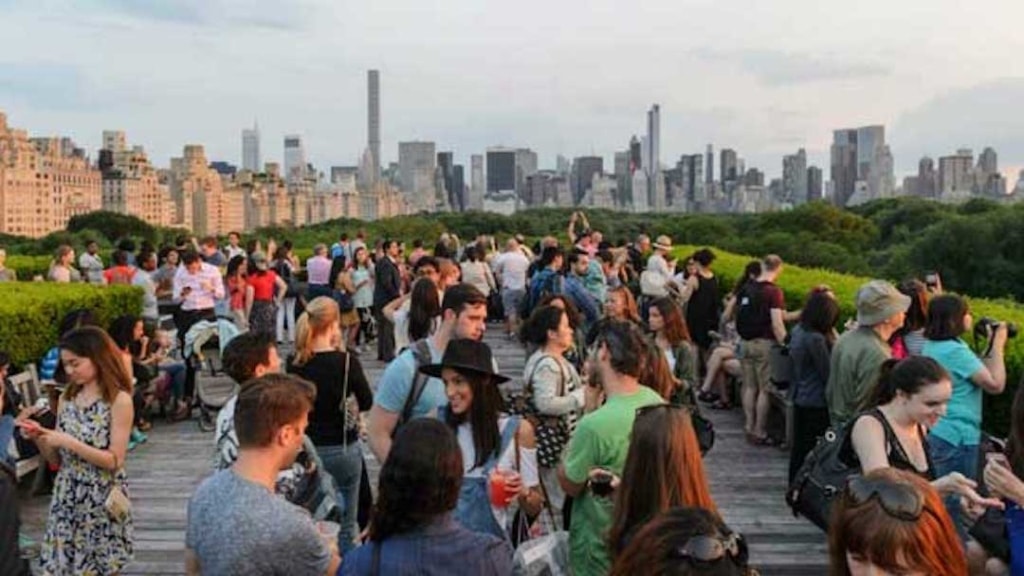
608;404;718;558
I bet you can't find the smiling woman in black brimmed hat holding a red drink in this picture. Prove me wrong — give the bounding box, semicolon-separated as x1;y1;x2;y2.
420;339;544;538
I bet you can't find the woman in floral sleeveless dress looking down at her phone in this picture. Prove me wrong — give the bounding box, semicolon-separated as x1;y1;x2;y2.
20;327;132;576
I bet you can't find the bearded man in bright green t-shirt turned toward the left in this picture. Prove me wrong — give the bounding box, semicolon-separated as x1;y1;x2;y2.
558;322;664;576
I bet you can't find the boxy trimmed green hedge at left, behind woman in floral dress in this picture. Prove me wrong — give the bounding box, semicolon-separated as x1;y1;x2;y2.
0;282;142;367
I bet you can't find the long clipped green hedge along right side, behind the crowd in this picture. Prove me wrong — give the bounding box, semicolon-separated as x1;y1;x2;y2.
676;246;1024;436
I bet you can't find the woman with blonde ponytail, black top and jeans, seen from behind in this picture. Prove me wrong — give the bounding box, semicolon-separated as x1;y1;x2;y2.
288;296;373;553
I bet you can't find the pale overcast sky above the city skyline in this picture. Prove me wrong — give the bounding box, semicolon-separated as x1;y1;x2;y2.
0;0;1024;181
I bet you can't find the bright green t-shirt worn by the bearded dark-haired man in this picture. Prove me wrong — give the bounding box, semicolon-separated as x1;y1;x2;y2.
564;386;665;576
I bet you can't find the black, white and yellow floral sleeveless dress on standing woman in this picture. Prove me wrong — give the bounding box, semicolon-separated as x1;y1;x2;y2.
42;400;132;576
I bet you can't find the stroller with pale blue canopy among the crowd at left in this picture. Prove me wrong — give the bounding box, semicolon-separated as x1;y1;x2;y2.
181;318;239;431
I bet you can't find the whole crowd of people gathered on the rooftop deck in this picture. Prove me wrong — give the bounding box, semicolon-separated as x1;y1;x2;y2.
0;213;1024;576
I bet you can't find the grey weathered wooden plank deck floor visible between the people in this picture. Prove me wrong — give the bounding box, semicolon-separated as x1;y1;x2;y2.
22;330;826;576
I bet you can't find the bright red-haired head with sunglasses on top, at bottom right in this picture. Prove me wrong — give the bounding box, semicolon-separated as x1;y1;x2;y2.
828;468;968;576
